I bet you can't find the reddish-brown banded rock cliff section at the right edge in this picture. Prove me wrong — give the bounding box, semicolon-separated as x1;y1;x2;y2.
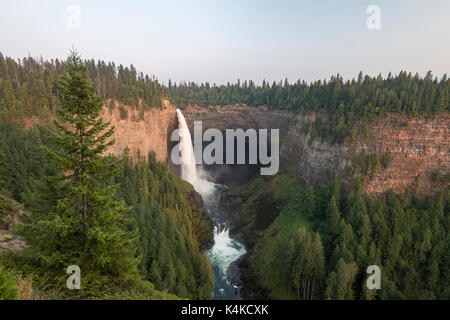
354;113;450;195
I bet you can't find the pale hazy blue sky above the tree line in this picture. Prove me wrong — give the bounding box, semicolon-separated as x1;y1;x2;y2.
0;0;450;83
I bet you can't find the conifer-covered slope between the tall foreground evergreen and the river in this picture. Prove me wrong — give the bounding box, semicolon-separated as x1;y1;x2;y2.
117;153;214;299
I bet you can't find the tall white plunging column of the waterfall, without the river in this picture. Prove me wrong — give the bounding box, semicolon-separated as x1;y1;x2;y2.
177;109;197;187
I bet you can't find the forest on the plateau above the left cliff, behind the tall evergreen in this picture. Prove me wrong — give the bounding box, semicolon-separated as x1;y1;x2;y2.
0;53;164;121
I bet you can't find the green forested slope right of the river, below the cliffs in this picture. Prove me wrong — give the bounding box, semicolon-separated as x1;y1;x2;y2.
233;175;450;300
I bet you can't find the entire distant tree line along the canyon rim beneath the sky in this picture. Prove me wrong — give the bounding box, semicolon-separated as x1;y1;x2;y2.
0;53;450;142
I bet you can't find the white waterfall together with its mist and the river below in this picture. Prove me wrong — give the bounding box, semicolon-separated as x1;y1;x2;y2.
177;109;246;299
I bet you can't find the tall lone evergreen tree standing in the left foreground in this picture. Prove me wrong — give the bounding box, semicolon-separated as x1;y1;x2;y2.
19;52;137;280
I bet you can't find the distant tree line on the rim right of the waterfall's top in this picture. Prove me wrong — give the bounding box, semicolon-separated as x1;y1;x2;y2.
167;71;450;142
